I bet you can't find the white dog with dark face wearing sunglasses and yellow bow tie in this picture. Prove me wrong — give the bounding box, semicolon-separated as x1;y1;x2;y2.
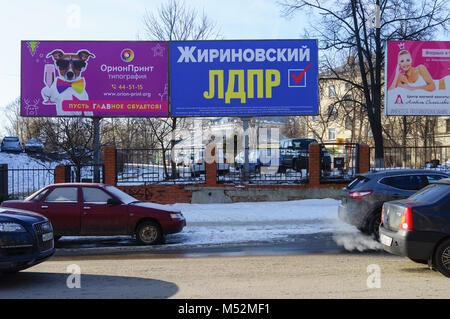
41;49;95;116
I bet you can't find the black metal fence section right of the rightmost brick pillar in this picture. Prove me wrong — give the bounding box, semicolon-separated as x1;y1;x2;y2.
370;145;450;170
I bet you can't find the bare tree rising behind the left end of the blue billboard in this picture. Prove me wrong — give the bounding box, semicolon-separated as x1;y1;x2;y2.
139;0;220;178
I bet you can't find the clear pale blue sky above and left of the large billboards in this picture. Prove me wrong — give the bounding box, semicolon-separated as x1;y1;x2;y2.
0;0;306;134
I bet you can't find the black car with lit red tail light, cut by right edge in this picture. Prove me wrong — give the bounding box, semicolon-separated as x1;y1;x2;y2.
380;178;450;277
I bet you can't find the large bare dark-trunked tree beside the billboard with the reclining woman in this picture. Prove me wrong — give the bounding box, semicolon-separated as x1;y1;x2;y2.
281;0;450;167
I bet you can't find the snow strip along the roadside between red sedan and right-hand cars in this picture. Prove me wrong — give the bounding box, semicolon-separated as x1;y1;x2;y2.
61;198;380;251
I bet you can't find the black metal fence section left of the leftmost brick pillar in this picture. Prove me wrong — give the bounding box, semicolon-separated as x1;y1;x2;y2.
0;164;55;200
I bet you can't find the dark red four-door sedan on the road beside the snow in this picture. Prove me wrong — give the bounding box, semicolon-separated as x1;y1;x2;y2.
1;183;186;245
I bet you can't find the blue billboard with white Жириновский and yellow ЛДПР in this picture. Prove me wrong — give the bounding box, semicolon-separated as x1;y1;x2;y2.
169;40;319;116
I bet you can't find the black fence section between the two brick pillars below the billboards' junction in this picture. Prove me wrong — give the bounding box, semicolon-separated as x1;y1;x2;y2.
116;147;205;185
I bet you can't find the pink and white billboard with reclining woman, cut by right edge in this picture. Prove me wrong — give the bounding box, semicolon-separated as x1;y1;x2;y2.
385;41;450;116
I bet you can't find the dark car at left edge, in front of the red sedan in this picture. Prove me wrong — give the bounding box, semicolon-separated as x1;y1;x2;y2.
0;208;55;273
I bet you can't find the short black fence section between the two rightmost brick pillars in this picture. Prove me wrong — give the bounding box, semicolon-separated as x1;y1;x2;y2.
320;143;359;183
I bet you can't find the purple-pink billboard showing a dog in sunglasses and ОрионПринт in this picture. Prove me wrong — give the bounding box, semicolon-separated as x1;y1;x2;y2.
21;41;168;117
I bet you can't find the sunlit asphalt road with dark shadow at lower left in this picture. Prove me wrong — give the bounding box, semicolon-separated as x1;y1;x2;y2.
0;233;450;299
